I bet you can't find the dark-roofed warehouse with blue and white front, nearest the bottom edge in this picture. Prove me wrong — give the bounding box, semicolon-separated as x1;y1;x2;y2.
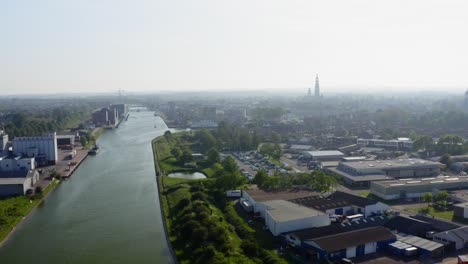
302;226;396;260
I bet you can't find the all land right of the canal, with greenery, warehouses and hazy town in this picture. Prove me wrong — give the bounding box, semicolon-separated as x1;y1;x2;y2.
153;83;468;263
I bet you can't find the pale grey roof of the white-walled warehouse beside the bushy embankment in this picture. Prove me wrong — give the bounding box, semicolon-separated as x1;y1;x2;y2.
263;200;325;222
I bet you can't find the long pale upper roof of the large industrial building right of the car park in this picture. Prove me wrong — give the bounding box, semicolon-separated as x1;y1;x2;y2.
342;159;440;170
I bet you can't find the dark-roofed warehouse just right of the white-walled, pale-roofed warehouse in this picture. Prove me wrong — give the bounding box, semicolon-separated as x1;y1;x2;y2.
290;191;388;217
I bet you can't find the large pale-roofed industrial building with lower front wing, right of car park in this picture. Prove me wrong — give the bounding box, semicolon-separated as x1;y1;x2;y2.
328;159;441;187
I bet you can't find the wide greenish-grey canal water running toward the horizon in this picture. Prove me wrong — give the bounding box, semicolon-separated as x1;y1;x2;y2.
0;111;172;264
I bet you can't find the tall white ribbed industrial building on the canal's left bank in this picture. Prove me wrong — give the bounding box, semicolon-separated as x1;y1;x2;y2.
13;132;58;166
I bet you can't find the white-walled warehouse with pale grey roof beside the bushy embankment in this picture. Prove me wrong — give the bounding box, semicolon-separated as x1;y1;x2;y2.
263;200;331;236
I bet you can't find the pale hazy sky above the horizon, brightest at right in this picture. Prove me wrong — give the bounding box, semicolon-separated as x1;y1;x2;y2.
0;0;468;94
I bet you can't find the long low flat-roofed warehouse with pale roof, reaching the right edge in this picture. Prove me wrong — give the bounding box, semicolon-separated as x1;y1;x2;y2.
370;176;468;200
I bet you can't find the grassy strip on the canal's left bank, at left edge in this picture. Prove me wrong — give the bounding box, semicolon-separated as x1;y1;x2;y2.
0;179;59;241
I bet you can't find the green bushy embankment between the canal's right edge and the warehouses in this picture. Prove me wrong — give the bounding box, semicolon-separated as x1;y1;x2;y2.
153;133;284;263
